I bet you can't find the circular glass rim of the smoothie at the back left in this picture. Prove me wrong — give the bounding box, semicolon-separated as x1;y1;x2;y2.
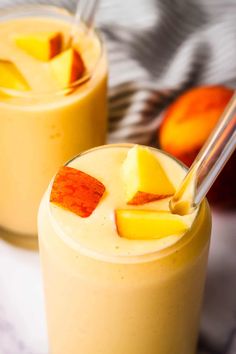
0;4;104;99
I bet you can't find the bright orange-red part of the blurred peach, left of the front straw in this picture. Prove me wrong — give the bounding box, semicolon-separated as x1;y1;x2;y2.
159;86;233;166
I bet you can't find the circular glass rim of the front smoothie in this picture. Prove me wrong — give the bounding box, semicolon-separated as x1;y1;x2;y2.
46;143;208;264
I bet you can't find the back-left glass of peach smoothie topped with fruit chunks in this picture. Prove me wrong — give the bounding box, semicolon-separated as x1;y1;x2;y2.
0;6;107;236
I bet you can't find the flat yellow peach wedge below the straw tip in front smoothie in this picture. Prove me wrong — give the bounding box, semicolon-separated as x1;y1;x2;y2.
115;209;188;240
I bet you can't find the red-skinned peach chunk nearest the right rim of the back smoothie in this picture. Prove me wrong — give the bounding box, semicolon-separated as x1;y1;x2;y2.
50;48;85;88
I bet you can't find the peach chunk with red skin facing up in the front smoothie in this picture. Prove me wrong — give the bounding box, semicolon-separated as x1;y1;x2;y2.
50;167;105;218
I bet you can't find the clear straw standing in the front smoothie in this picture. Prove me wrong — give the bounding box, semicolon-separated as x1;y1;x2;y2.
170;91;236;215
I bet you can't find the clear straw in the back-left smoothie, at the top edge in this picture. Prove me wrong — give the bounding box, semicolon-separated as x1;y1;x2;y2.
66;0;99;48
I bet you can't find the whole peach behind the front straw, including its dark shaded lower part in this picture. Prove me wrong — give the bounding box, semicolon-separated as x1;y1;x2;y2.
159;86;236;208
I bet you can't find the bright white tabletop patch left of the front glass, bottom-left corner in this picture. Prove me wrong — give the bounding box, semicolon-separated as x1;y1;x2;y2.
0;240;48;354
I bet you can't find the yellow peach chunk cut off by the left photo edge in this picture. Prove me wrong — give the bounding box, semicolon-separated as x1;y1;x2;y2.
0;60;30;91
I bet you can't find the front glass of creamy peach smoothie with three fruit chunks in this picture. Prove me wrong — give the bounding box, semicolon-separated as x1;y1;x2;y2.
38;144;211;354
